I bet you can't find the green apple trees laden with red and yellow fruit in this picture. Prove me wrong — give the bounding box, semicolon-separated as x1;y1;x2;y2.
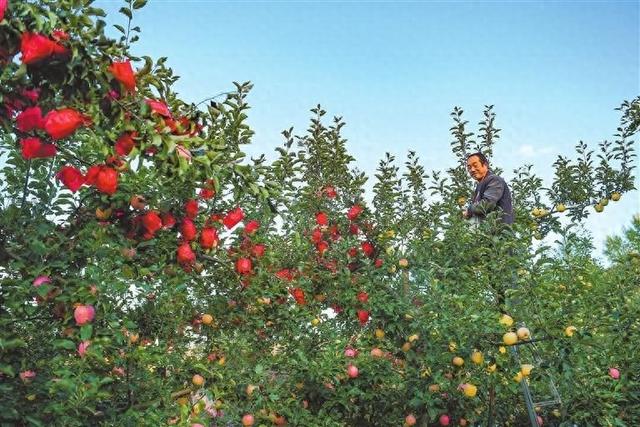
0;0;640;426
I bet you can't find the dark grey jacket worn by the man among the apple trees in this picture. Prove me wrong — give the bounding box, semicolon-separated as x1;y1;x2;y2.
467;171;513;224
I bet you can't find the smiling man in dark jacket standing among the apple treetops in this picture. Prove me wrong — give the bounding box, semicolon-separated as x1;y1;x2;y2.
462;153;513;224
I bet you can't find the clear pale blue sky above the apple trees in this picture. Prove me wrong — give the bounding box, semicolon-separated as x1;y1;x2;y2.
95;0;640;258
